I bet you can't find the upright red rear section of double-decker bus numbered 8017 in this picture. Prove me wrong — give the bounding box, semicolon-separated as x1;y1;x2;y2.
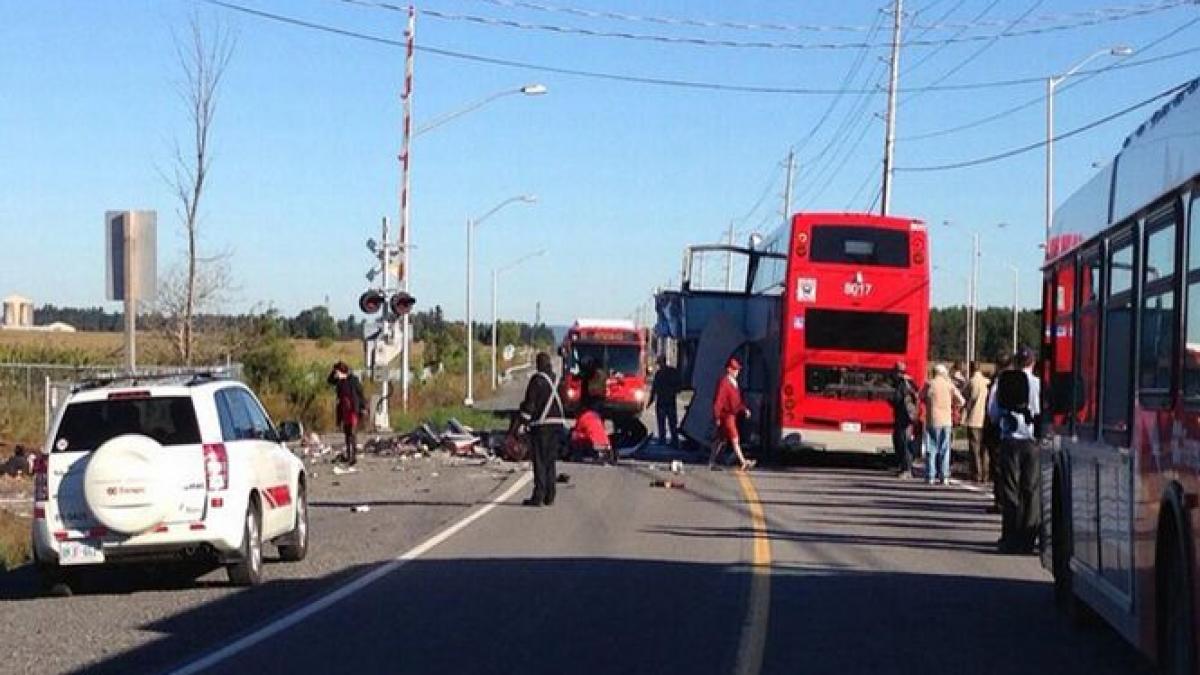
755;213;929;452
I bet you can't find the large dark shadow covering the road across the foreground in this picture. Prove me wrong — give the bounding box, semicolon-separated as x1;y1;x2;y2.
64;554;1144;675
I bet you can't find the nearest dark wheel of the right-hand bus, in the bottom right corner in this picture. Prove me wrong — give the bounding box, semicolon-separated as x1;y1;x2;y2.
1158;527;1196;675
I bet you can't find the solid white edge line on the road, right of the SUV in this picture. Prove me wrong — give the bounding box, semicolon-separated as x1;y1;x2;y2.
170;472;533;675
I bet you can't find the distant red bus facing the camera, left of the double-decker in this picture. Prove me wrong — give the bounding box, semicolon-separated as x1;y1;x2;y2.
559;318;649;417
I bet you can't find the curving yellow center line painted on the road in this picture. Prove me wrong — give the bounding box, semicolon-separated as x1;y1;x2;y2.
733;473;770;675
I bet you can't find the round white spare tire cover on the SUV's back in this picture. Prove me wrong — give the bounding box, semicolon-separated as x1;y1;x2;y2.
83;434;174;534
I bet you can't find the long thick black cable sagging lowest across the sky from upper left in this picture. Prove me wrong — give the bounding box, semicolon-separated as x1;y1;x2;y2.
193;0;1200;96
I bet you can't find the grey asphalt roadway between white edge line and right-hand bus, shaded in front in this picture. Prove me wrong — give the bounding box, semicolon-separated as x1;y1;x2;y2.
84;446;1145;675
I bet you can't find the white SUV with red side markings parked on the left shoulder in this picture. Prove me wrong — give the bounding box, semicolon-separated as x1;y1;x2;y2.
34;374;308;587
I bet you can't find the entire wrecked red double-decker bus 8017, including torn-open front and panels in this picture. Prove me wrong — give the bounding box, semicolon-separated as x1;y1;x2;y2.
655;213;929;453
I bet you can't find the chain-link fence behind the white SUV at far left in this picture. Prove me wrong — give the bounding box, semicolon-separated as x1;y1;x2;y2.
0;363;242;432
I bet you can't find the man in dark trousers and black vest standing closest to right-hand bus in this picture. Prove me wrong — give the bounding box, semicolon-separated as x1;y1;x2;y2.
988;347;1042;554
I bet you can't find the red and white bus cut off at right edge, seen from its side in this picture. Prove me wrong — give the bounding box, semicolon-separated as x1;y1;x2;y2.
1040;79;1200;673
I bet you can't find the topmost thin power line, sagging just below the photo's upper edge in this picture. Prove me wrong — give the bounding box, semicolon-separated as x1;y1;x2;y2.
436;0;1194;32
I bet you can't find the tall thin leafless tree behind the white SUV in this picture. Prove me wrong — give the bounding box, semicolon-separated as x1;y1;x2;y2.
163;14;236;365
